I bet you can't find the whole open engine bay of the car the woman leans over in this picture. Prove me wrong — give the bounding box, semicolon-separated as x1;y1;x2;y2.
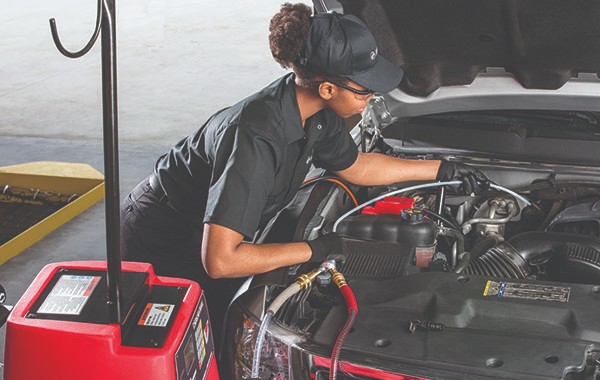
223;107;600;380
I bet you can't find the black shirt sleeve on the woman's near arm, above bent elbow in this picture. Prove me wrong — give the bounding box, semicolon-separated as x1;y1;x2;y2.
204;125;277;238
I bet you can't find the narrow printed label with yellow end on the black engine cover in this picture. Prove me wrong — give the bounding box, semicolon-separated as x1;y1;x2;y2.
483;280;571;302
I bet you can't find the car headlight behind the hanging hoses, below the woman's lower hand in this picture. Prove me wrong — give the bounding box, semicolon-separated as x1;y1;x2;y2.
231;310;291;380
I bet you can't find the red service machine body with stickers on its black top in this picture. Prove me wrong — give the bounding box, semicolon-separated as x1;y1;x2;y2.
4;261;219;380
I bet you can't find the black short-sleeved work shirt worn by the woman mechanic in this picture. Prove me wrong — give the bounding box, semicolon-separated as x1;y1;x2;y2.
155;74;358;239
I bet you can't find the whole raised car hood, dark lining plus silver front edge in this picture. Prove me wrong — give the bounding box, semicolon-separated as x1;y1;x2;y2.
315;0;600;116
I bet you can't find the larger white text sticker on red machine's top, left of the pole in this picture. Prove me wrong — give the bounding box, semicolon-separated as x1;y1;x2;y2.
38;275;101;315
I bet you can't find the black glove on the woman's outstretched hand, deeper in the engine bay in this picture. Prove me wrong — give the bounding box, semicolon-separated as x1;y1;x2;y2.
436;160;490;195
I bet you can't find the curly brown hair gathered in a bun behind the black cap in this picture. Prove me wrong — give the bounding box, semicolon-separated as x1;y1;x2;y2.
269;3;315;87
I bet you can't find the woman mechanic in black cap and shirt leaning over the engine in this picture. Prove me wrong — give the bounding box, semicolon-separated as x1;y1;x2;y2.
122;3;486;340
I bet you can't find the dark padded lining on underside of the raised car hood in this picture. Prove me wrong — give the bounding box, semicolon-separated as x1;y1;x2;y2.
317;0;600;97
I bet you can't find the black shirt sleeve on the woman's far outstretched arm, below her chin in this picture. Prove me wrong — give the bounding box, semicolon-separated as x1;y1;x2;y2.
314;116;358;171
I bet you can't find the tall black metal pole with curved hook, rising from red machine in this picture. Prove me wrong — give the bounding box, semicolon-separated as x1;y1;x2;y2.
50;0;122;324
